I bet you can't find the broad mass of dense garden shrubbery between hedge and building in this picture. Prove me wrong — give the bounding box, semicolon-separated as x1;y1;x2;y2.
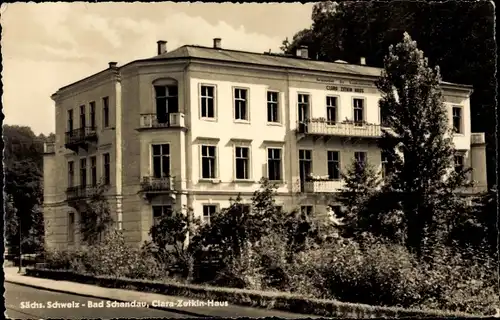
46;182;498;314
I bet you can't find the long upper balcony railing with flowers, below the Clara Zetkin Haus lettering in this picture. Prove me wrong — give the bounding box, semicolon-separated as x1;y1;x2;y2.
297;119;382;138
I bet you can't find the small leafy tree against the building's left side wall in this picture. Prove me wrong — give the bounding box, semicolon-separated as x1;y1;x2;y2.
79;182;114;245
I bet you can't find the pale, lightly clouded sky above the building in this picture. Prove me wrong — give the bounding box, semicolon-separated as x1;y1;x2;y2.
0;2;313;134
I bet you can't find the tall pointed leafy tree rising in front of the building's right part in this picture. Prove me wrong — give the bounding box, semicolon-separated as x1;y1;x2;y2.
376;33;469;254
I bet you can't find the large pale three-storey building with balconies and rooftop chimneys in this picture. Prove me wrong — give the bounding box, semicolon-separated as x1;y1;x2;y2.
44;39;486;247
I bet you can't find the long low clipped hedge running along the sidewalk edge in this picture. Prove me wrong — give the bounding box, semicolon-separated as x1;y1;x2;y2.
26;268;477;318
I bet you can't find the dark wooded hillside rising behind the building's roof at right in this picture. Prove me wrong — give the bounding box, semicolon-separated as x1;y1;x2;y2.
284;1;497;186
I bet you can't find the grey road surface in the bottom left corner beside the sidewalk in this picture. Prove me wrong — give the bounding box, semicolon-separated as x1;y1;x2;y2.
4;283;193;319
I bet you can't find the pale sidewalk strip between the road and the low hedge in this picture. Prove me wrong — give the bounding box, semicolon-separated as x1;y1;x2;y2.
4;267;320;319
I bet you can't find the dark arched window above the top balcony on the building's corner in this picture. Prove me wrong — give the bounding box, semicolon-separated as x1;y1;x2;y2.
153;79;179;125
